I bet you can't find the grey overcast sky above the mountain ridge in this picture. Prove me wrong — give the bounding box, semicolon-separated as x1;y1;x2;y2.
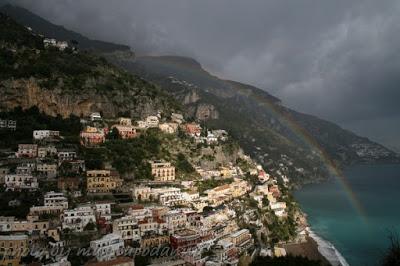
16;0;400;149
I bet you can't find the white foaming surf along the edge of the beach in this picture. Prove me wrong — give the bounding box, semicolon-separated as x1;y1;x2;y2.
307;227;349;266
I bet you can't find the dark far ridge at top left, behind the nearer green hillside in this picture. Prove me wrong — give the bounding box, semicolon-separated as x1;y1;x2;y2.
0;3;130;53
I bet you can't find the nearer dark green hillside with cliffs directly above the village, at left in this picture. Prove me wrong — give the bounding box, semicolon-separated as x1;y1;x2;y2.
0;13;177;117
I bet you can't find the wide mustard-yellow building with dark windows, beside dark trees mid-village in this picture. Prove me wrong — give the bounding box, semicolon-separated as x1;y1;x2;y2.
86;170;122;193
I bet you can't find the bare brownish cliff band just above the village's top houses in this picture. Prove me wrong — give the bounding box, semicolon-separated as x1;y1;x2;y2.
0;78;173;117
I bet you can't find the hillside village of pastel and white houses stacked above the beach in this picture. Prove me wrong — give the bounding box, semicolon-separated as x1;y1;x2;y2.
0;108;312;265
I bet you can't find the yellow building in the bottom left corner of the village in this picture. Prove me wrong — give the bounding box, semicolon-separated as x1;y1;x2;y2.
0;235;28;266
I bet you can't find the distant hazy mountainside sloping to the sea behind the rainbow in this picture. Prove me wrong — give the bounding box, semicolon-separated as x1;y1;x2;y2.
111;54;399;182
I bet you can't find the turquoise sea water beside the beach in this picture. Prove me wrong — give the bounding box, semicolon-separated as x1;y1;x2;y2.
295;165;400;266
